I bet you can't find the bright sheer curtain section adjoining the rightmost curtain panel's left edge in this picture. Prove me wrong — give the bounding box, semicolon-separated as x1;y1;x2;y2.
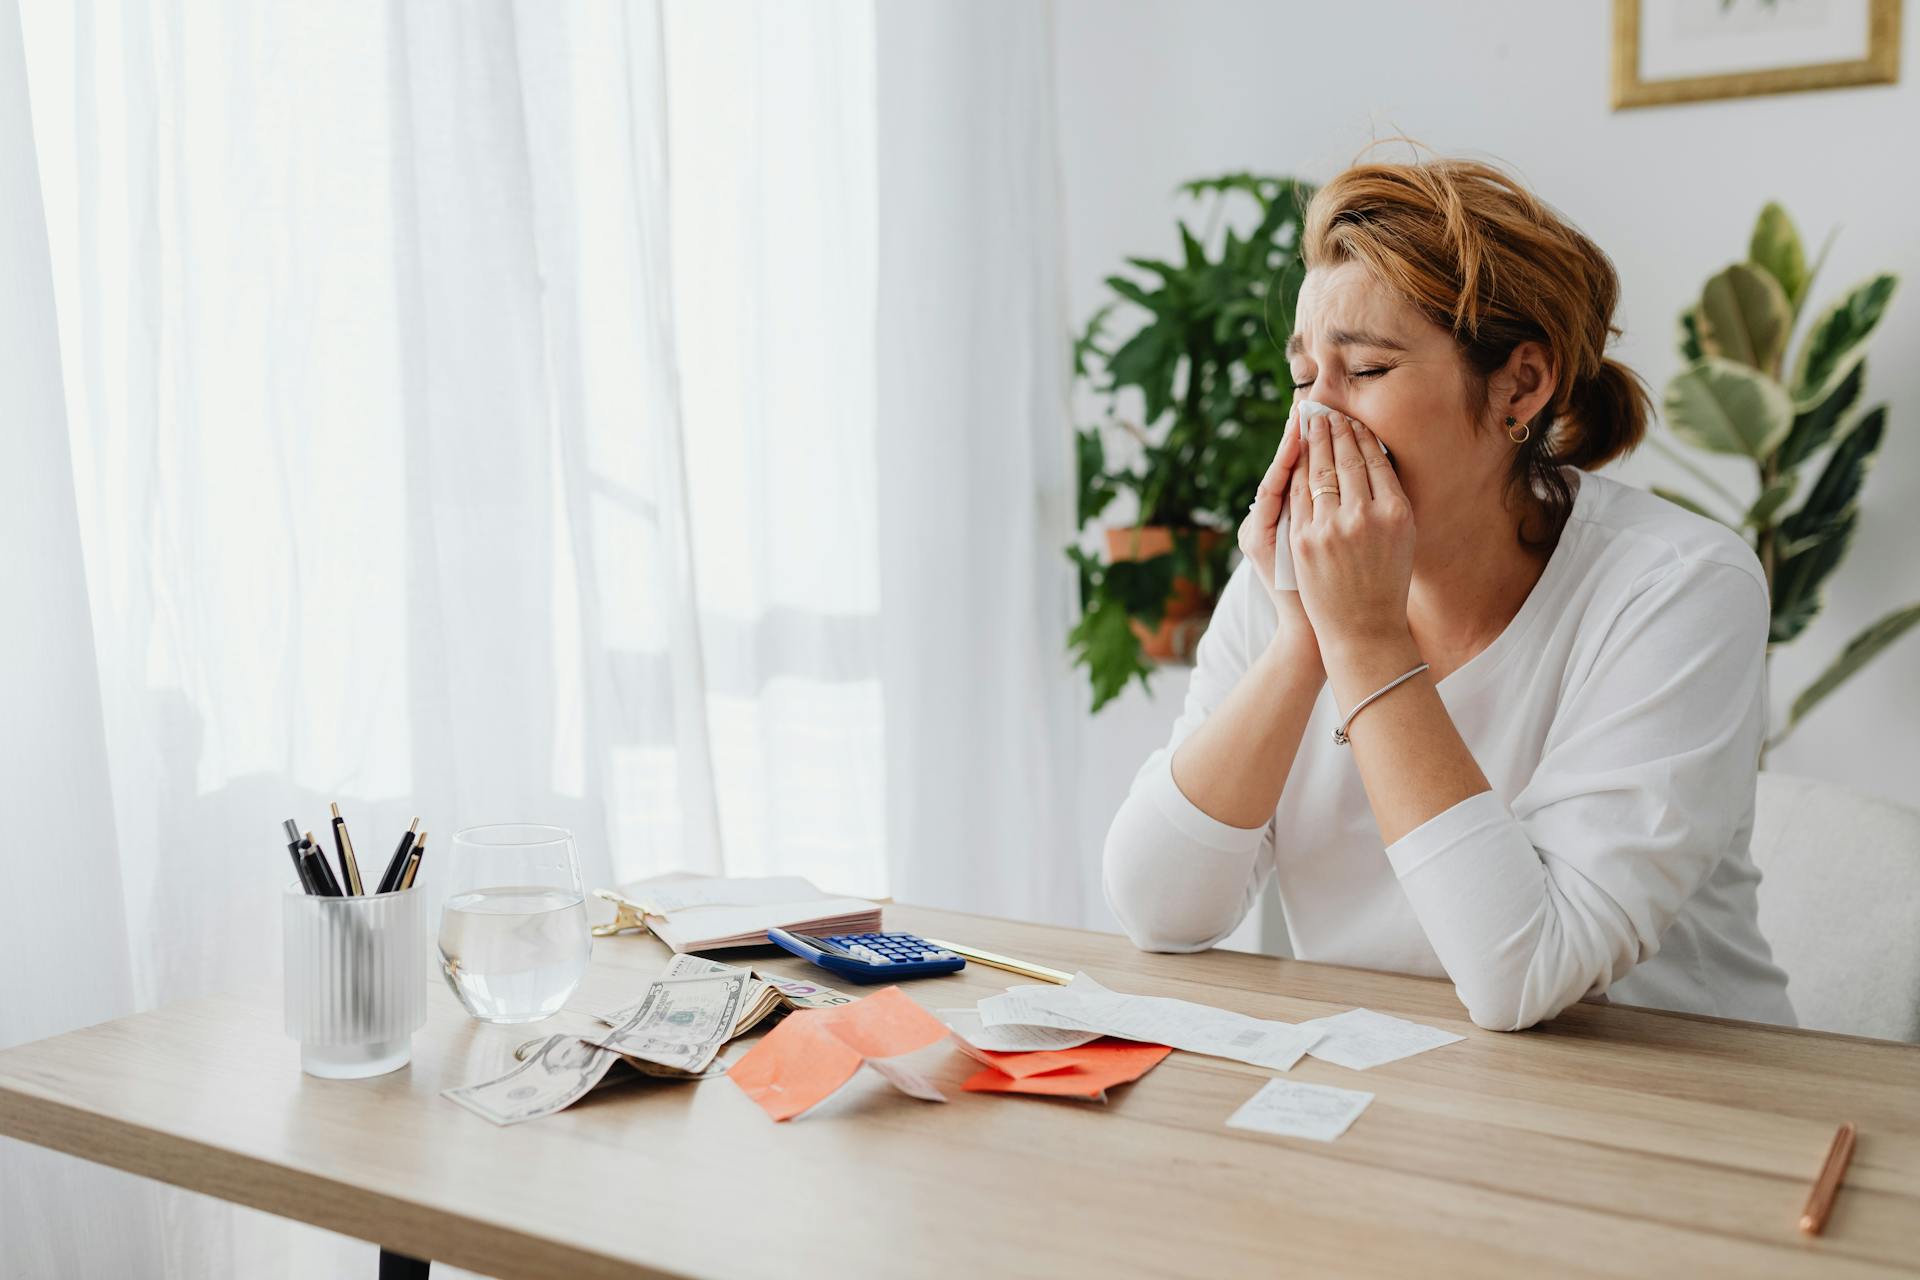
666;0;889;894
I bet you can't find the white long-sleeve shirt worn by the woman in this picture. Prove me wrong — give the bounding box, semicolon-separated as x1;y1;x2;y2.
1104;470;1795;1031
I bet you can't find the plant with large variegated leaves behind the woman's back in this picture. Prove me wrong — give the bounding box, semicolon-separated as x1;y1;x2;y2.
1653;203;1920;760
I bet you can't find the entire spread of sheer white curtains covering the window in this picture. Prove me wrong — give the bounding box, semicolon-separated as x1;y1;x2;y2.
0;0;1085;1276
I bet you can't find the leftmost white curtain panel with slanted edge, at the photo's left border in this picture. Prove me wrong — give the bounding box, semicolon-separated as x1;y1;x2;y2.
0;0;159;1276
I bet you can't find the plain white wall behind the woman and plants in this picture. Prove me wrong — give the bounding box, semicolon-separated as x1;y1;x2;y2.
1054;0;1920;923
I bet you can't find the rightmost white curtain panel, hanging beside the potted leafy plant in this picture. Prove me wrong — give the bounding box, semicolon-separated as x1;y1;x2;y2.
877;0;1098;925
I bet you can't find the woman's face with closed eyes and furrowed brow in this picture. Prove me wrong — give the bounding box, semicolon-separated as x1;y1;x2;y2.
1286;263;1509;526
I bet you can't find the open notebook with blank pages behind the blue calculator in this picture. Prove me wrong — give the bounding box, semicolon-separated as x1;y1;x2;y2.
595;875;879;952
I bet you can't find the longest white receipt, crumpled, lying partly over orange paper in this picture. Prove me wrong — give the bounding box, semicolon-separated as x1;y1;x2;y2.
979;973;1325;1071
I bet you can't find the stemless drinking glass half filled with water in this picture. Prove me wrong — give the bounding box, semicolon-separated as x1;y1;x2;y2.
440;825;593;1023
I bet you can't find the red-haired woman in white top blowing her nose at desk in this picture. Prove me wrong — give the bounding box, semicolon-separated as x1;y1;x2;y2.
1106;159;1793;1031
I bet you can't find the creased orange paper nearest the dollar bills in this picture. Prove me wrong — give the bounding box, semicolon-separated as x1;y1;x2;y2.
728;986;947;1121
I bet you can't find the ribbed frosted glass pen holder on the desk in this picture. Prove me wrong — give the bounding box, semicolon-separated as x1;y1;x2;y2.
280;885;426;1080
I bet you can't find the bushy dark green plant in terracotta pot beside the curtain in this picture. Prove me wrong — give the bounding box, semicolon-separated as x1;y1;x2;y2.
1068;173;1313;710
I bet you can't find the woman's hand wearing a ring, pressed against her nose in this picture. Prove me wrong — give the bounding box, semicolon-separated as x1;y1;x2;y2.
1288;413;1413;651
